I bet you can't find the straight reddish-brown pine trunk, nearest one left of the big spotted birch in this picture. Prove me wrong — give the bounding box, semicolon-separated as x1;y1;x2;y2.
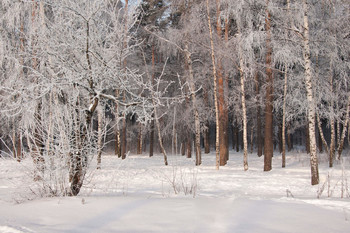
264;0;273;171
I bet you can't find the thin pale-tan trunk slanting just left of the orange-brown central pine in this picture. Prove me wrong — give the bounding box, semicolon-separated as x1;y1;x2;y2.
206;0;220;170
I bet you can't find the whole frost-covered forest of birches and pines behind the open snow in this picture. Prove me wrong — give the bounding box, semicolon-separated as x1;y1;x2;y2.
0;0;350;232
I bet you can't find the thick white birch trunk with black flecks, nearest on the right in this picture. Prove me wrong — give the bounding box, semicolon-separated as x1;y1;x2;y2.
303;0;319;185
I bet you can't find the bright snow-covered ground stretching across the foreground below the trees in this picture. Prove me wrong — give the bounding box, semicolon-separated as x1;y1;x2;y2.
0;151;350;233
